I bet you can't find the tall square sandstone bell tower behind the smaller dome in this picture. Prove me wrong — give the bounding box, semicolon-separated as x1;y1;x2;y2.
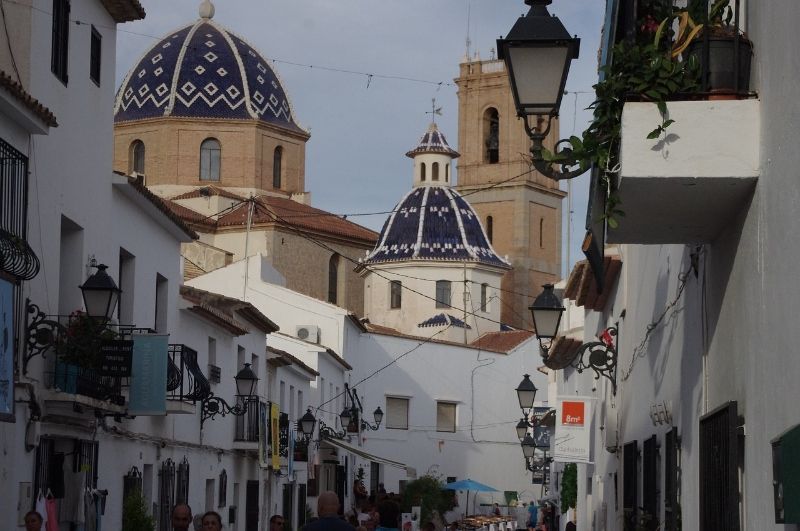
455;59;566;329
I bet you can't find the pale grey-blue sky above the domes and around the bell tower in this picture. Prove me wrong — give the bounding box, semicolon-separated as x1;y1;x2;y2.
116;0;605;275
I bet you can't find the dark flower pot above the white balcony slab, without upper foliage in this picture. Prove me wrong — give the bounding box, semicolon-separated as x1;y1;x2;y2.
686;36;753;93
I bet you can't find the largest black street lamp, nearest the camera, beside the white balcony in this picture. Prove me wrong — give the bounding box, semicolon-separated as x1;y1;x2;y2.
497;0;586;180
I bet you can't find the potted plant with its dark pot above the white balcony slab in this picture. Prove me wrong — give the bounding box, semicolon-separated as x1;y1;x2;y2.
686;0;753;95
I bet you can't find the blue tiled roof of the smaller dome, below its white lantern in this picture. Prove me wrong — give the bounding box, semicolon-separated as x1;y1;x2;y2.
364;186;511;269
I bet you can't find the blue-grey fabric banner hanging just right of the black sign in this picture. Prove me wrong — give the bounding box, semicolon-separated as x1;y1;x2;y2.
128;334;169;415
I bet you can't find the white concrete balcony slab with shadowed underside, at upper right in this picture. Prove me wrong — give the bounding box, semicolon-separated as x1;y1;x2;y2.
607;99;761;244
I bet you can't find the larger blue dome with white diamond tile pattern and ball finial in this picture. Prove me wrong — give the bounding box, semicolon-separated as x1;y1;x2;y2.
114;7;303;131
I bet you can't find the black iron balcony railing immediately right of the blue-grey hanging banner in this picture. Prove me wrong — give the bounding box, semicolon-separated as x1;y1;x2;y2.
166;344;211;414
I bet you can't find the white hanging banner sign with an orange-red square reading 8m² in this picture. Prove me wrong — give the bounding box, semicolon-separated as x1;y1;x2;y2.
553;396;594;463
